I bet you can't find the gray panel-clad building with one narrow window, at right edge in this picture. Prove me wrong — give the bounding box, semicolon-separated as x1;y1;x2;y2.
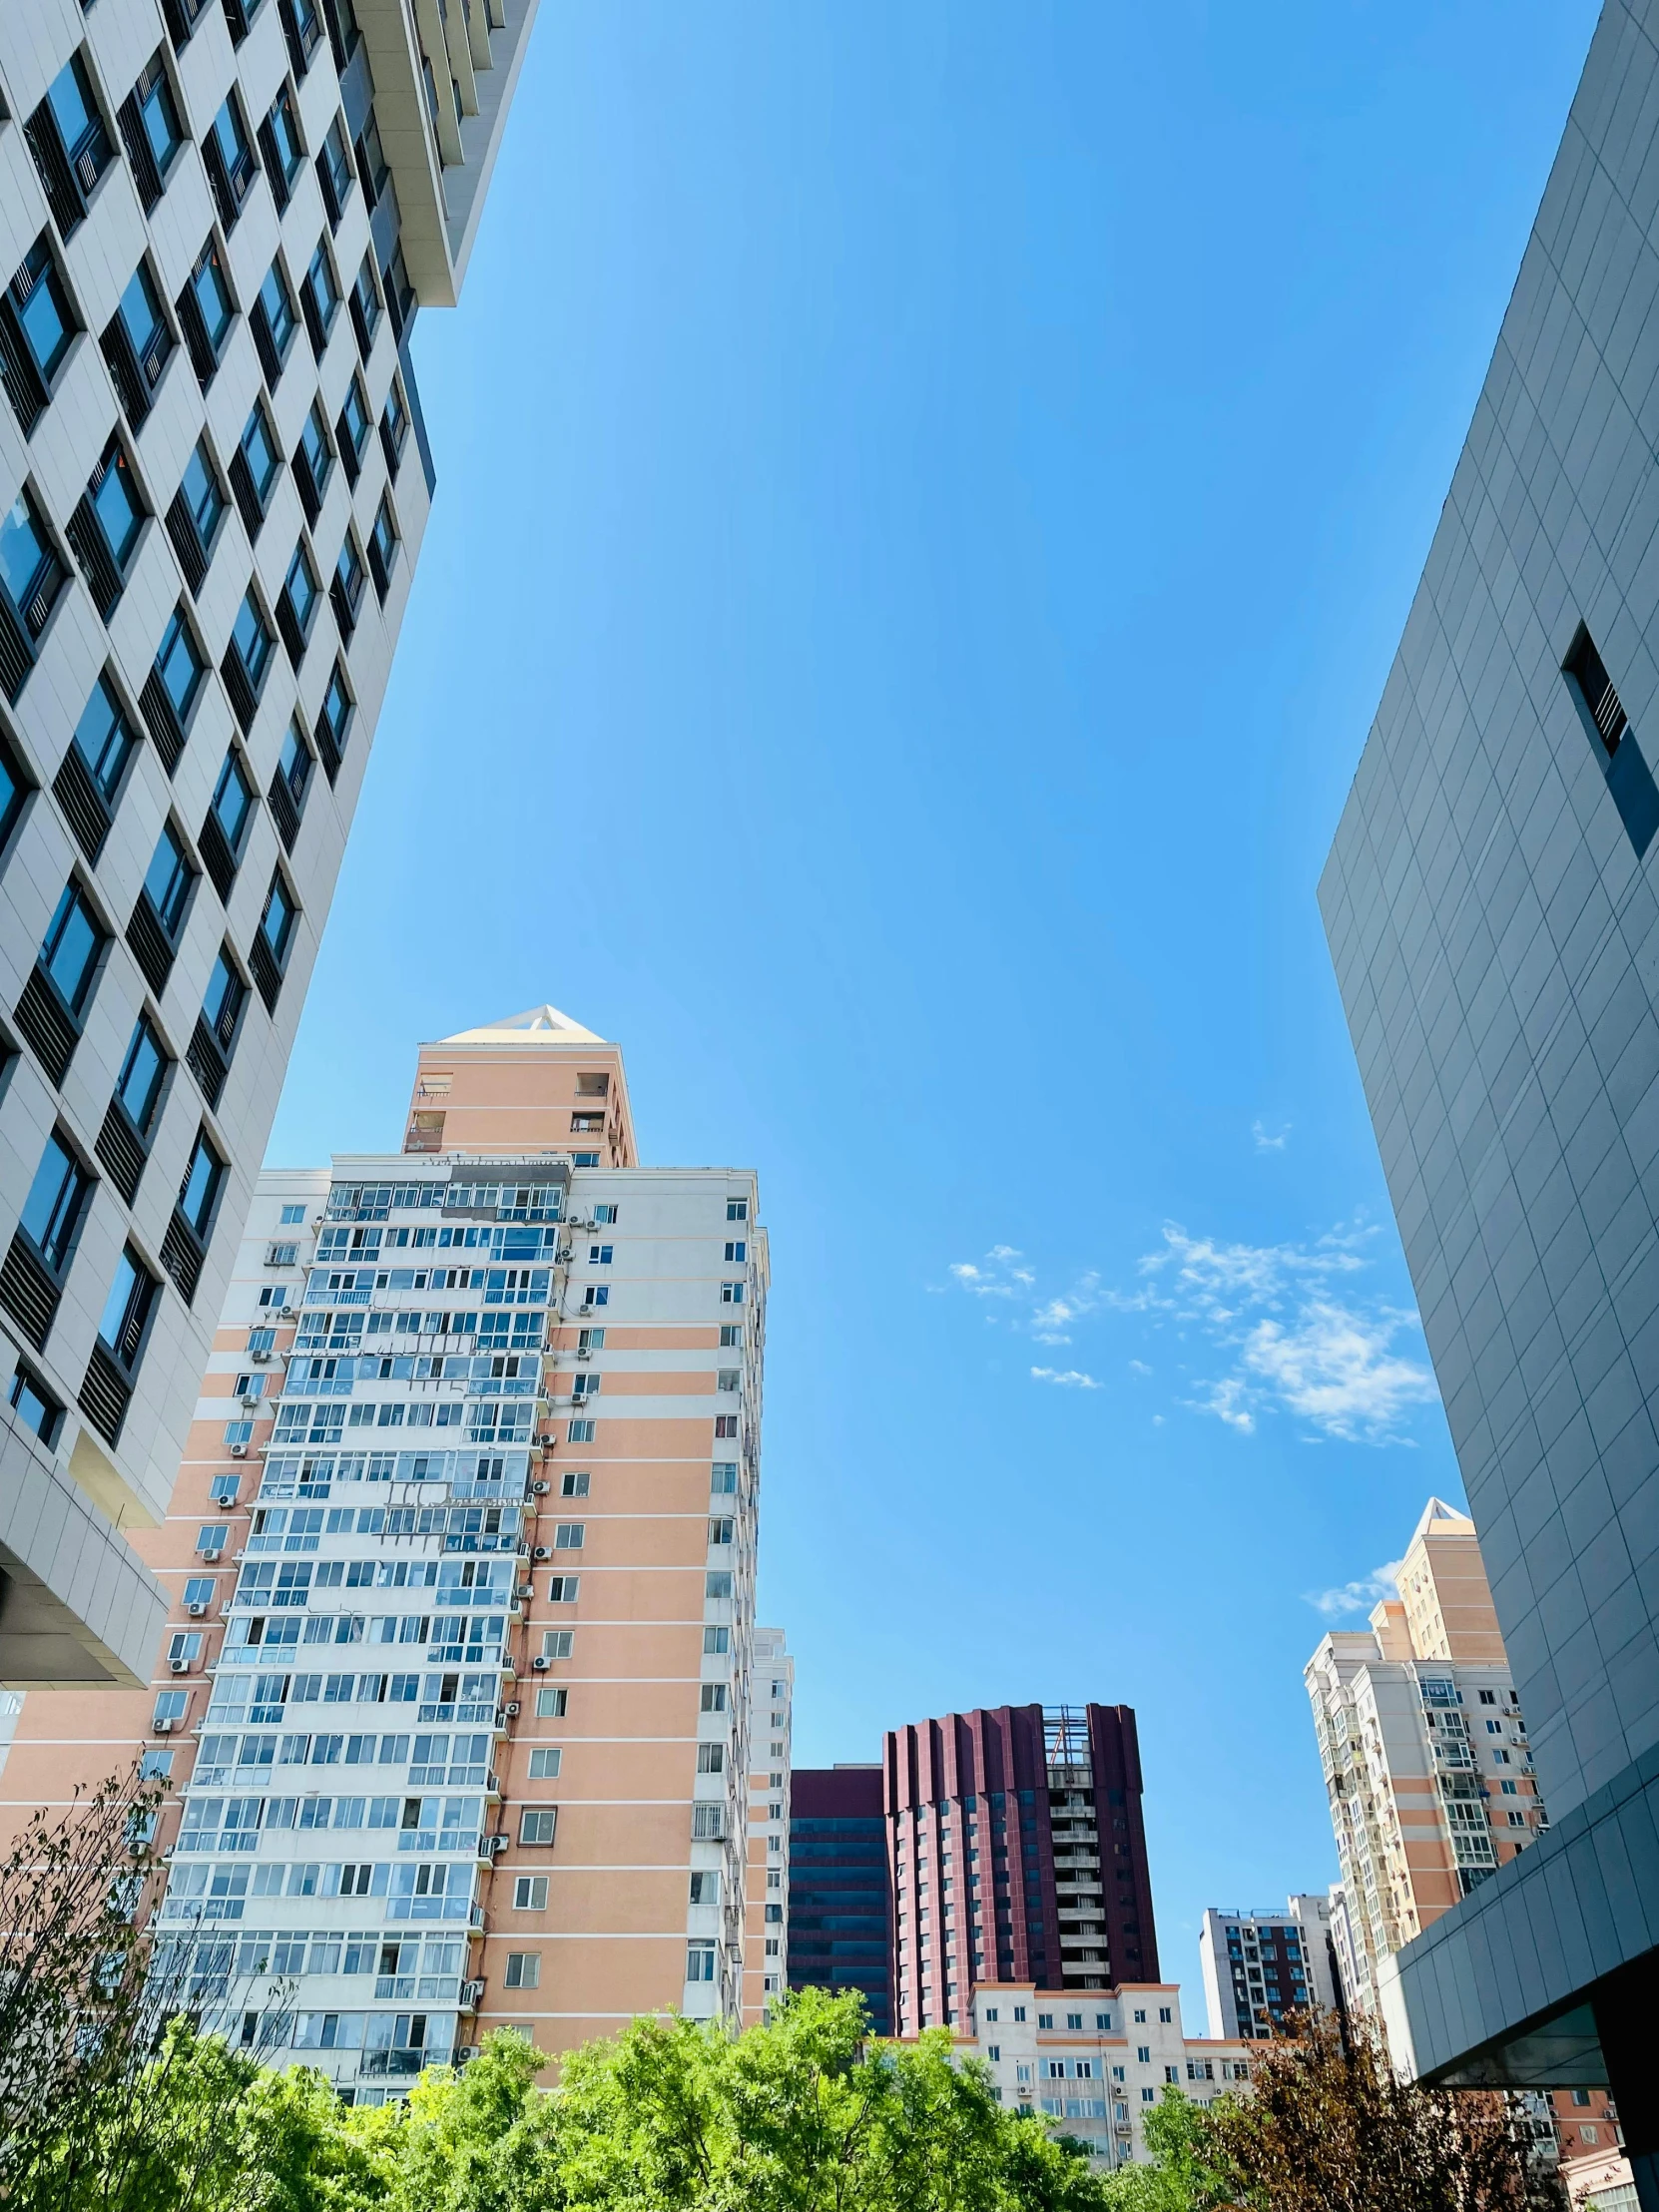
1321;0;1659;2208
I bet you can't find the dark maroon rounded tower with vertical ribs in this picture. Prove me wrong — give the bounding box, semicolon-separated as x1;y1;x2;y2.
884;1706;1157;2035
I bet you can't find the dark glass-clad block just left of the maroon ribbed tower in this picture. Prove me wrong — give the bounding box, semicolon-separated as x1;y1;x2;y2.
790;1765;893;2035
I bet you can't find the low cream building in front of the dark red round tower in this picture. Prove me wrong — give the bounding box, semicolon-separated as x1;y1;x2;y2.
958;1982;1252;2168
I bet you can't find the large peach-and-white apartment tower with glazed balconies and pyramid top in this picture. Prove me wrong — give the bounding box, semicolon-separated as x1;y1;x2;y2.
0;1008;768;2099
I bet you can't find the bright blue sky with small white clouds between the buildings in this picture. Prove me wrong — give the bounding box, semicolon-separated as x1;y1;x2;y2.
273;0;1595;2004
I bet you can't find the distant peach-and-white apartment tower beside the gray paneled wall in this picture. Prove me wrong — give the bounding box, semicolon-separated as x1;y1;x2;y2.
1305;1497;1548;2017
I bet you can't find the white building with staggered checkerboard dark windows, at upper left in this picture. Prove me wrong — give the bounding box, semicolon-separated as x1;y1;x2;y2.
0;0;535;1686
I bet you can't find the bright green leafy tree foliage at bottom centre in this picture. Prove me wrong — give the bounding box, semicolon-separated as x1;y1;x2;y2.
336;1990;1106;2212
